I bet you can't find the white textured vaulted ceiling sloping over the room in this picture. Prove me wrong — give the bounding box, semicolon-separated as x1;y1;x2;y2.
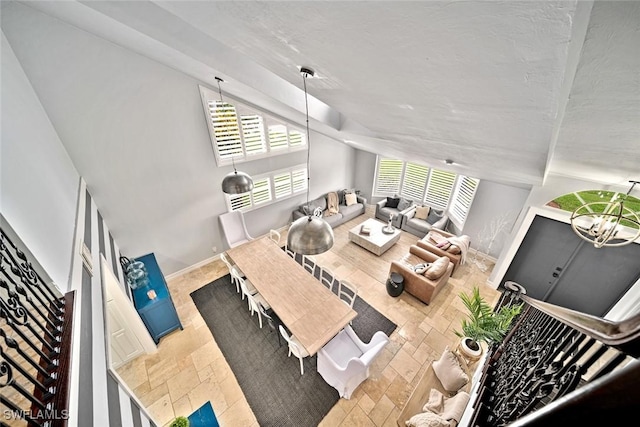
6;1;640;186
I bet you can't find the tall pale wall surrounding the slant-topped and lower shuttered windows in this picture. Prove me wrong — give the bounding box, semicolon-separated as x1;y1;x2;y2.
3;4;354;274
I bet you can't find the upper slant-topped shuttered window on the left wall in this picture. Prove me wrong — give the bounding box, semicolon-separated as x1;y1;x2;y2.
200;86;307;166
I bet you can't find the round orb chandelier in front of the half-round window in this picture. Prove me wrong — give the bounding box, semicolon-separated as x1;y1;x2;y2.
571;181;640;248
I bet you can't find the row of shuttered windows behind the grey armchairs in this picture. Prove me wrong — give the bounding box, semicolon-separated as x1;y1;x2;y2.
373;157;479;227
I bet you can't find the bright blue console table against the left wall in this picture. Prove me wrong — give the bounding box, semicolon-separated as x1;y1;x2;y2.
133;253;182;344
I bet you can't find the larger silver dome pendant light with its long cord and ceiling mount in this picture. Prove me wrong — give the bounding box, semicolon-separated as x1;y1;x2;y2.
287;67;333;255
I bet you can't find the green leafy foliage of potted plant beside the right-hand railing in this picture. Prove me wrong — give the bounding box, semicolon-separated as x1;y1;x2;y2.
454;286;522;344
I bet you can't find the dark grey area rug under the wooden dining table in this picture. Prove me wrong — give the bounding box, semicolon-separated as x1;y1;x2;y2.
191;275;397;427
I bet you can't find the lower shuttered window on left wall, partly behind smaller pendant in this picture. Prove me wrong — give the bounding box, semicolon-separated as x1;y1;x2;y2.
225;165;308;212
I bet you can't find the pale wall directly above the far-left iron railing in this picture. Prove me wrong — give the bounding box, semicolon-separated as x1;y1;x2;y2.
0;33;80;291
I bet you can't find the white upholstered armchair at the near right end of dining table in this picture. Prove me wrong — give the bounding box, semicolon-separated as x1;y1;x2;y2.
318;325;389;399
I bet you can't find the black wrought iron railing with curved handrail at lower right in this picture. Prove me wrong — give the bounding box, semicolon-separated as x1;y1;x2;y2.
469;282;640;427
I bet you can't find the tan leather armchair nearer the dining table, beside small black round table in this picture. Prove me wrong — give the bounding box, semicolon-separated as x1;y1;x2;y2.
389;245;453;304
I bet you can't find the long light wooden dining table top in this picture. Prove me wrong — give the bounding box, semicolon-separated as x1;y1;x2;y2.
227;237;357;355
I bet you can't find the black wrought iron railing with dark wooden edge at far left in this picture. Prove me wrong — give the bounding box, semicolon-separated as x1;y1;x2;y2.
0;230;73;427
